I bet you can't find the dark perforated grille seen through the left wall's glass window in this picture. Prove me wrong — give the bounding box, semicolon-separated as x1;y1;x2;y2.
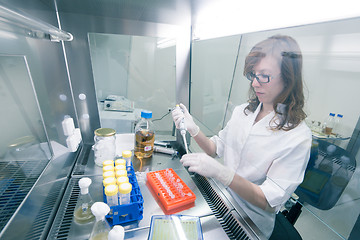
0;160;48;231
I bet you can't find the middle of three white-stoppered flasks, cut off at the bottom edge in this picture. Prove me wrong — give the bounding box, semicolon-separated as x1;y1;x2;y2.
90;202;111;240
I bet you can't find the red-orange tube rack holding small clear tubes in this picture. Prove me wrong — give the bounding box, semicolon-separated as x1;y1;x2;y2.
146;168;196;211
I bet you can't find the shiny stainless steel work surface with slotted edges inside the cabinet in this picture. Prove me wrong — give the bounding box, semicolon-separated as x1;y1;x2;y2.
47;142;263;240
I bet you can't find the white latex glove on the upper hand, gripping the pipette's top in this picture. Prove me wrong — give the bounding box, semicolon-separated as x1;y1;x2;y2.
171;103;200;137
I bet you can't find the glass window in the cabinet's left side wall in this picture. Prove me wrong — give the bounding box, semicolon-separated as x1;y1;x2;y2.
0;55;51;231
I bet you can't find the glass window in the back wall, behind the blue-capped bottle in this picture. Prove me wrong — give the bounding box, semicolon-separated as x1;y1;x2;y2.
88;33;176;134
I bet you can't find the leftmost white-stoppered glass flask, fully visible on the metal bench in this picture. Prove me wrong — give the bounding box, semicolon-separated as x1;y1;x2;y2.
74;177;94;224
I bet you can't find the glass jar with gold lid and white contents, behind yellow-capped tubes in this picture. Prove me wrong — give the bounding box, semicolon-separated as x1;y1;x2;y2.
92;128;116;167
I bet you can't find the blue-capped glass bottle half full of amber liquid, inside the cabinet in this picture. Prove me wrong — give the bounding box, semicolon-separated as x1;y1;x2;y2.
134;110;155;158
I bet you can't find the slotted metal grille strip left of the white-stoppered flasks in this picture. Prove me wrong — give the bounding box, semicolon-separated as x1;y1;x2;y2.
48;179;80;239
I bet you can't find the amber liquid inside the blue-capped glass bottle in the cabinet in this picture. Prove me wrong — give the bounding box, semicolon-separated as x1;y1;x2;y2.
134;130;155;158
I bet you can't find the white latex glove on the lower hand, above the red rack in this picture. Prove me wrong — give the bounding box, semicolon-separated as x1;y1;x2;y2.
180;153;235;187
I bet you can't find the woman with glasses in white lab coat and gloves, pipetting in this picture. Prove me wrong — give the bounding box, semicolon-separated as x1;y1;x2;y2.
172;35;312;238
